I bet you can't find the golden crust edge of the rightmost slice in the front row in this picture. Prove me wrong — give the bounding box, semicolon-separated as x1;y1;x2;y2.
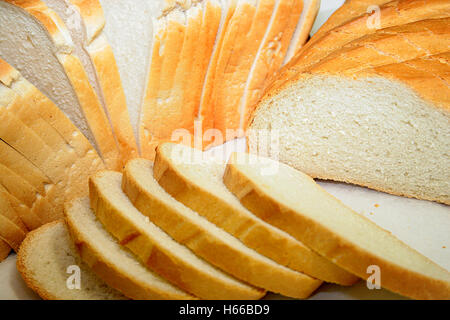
227;158;450;300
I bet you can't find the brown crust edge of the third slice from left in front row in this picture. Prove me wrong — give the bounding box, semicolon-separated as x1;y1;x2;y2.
89;171;265;299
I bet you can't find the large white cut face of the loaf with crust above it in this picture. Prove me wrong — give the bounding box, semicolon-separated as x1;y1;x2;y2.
249;53;450;204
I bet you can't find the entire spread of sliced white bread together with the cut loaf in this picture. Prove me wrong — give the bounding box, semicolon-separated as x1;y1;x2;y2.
0;0;450;299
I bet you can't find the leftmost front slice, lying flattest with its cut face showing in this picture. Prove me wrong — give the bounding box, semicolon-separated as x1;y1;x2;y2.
17;220;125;300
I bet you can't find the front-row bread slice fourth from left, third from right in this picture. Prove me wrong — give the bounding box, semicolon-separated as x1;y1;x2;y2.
122;159;321;298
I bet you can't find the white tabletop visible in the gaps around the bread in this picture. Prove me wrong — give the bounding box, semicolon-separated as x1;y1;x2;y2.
0;0;450;300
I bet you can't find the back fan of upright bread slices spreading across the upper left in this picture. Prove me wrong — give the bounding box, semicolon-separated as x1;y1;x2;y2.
0;0;320;260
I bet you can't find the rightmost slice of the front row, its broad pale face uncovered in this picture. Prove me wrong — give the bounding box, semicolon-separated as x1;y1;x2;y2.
224;154;450;299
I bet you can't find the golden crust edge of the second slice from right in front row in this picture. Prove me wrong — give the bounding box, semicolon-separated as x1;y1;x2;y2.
153;144;357;285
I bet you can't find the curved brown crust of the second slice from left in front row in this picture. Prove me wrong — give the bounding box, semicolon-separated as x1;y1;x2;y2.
65;200;196;300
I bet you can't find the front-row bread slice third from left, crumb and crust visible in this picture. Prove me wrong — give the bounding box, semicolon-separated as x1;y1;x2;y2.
90;171;265;299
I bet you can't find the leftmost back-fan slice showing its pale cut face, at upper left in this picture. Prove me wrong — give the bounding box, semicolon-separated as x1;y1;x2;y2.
0;0;121;168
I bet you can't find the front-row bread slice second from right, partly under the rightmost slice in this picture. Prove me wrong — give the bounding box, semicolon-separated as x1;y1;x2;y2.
154;143;357;285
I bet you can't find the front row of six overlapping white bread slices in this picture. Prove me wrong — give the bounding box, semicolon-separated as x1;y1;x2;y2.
17;143;450;300
